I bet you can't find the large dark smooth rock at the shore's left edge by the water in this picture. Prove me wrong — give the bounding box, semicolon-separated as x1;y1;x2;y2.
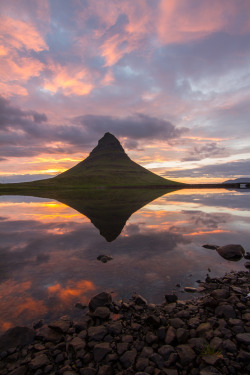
0;327;35;352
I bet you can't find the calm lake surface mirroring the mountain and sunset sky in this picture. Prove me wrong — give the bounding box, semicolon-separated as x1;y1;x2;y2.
0;189;250;331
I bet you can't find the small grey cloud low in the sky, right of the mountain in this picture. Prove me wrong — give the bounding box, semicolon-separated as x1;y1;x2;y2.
182;142;228;161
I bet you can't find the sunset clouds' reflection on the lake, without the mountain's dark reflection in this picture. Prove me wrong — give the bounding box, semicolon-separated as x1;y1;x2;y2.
0;192;249;330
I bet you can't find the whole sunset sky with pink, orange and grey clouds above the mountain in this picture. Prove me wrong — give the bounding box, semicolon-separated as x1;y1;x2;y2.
0;0;250;183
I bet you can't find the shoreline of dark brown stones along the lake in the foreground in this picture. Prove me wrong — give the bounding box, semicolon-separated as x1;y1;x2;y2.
0;272;250;375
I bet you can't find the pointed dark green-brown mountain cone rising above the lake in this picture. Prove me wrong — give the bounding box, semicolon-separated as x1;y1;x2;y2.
50;133;180;188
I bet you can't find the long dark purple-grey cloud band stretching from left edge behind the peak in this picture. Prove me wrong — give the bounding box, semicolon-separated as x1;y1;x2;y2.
0;97;187;157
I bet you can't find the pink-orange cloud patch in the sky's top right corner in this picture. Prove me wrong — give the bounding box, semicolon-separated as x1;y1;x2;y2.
157;0;250;43
